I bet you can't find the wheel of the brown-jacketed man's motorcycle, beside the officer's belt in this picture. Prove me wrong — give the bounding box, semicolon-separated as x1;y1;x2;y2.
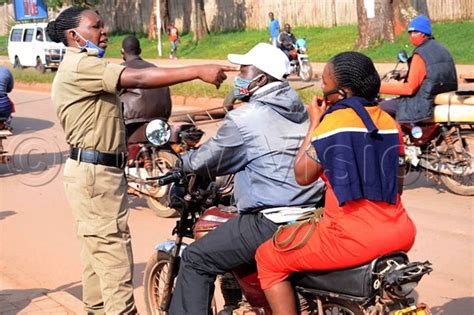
146;151;179;218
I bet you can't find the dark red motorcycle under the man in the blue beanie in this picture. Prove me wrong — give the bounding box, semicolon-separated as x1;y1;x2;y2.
382;50;474;196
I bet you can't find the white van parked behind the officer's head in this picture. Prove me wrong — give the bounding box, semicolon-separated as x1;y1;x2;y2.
8;23;66;72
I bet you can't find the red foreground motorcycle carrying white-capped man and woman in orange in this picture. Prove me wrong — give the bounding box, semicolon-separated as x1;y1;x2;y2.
144;119;432;315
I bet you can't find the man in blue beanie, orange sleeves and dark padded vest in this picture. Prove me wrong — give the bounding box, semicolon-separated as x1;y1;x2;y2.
380;15;458;122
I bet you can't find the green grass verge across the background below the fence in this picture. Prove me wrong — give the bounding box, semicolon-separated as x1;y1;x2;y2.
0;20;474;64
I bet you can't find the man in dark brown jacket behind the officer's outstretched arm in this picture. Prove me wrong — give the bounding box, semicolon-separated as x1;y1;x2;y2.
119;35;172;161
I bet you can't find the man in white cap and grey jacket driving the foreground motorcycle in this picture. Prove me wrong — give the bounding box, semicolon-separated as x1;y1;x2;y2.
169;43;324;315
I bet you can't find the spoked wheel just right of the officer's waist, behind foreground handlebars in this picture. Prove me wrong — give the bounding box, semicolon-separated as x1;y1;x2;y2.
146;151;179;218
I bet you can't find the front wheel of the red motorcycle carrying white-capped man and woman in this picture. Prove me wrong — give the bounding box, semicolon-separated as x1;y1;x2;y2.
143;252;217;315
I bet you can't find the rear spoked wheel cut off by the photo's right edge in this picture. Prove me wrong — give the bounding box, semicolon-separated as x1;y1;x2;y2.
440;132;474;196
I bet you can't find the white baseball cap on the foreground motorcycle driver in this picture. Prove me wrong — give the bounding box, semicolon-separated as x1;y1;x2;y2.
227;43;290;81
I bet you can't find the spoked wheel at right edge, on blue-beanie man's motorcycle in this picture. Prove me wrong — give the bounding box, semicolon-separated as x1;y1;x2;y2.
440;133;474;196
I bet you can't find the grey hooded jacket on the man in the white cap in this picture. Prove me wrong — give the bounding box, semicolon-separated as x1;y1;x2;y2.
183;82;324;213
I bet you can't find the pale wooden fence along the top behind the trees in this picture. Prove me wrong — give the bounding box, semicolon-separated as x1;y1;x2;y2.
0;0;474;34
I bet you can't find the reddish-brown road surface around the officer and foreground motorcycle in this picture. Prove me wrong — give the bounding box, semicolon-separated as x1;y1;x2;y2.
0;91;474;315
